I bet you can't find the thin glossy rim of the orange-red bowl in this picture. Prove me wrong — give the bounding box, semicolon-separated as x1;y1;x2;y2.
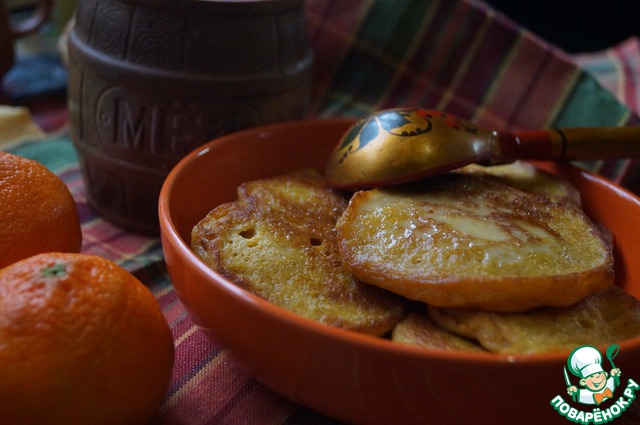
158;118;640;366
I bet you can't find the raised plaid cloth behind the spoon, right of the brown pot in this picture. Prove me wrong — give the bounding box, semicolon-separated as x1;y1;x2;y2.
307;0;638;189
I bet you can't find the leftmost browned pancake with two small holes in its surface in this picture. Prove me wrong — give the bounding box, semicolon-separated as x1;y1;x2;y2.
191;172;406;335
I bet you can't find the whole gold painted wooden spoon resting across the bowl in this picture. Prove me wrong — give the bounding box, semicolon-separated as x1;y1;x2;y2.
326;108;640;189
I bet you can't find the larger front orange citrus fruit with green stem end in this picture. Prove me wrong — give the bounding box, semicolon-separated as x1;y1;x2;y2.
0;253;174;425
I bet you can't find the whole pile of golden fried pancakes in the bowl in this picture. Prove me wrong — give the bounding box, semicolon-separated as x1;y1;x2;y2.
192;162;640;354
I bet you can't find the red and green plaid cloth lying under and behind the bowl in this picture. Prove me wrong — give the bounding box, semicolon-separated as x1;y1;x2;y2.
0;0;640;425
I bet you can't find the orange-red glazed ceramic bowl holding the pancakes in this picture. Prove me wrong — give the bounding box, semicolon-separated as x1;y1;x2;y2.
159;120;640;424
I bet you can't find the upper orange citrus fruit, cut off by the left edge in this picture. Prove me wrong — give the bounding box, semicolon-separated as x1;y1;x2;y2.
0;152;82;268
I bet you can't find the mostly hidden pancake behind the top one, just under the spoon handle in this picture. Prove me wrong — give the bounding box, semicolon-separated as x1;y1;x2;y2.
457;161;581;205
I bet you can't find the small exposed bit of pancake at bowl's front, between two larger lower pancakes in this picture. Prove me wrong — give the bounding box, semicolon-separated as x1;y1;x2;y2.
391;306;486;352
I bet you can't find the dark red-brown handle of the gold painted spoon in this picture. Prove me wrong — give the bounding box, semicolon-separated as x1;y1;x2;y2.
492;127;640;160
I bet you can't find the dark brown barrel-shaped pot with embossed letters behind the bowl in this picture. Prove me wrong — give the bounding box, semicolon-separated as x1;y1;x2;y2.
69;0;312;234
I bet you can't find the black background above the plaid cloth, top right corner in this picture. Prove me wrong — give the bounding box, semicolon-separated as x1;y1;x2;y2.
485;0;640;53
